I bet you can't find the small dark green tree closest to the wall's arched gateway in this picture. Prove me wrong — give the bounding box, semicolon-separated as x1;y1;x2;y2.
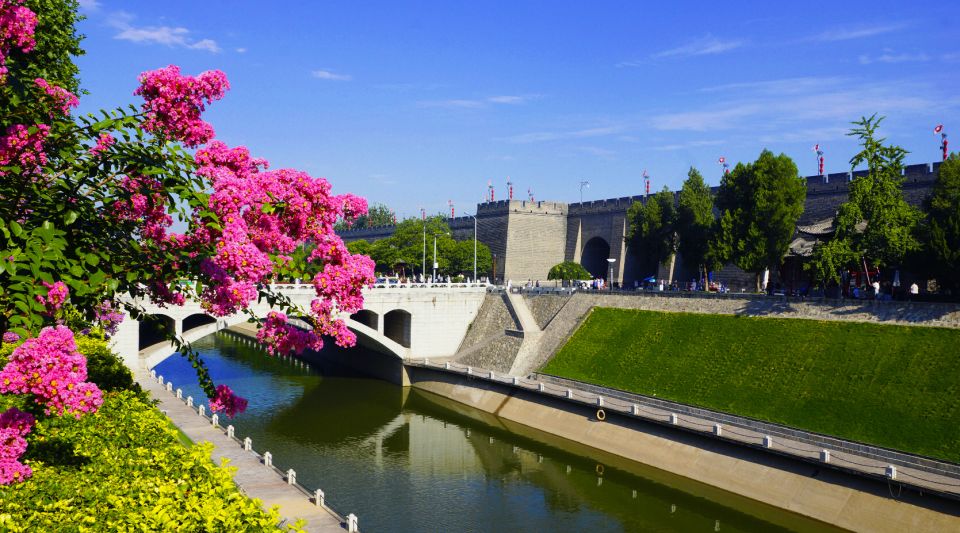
627;187;677;276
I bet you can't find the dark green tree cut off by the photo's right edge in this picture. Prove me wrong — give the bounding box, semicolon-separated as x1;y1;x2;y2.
924;153;960;289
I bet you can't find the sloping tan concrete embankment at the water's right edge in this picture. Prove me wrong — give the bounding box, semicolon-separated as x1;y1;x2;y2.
407;367;960;532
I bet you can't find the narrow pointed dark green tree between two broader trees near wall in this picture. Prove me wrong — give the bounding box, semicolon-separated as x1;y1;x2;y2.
677;167;716;276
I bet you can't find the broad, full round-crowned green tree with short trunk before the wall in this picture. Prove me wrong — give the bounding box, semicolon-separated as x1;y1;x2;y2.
710;150;807;291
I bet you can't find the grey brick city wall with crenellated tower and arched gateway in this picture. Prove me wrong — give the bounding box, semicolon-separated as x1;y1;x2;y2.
340;163;940;290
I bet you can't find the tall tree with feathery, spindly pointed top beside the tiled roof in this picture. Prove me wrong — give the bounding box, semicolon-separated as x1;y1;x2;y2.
807;114;922;283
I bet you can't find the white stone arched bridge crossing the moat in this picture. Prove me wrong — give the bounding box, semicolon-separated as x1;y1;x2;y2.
112;283;486;368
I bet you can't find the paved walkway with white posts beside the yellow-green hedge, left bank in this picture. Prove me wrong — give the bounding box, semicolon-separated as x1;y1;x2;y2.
134;370;346;533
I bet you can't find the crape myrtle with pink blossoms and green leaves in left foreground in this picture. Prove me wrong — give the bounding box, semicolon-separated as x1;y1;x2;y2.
0;0;373;483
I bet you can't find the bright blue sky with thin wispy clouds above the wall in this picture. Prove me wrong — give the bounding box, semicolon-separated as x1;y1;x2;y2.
78;0;960;216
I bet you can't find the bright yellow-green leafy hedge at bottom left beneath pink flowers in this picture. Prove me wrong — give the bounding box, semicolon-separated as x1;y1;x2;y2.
0;339;300;532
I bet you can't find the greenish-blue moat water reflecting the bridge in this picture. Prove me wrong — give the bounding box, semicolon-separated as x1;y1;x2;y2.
156;333;830;532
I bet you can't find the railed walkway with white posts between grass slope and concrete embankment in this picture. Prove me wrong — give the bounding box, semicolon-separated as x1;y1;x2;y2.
405;359;960;499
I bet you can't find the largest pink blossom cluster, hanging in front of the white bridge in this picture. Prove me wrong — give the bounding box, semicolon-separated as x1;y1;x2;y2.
193;141;373;330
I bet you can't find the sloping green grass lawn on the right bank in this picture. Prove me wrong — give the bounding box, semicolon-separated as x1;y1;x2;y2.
543;308;960;462
